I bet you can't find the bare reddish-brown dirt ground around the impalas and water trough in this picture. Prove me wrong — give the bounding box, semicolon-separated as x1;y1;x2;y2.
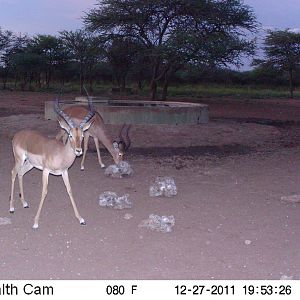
0;91;300;279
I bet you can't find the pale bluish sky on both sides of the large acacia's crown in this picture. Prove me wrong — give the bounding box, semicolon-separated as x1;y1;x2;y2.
0;0;300;35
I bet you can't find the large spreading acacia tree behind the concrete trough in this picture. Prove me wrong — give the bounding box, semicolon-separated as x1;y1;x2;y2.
84;0;256;99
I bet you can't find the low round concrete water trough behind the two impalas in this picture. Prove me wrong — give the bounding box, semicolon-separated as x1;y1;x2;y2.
45;97;209;124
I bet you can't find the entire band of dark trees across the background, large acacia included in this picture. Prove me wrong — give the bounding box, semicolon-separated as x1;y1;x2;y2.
0;0;300;99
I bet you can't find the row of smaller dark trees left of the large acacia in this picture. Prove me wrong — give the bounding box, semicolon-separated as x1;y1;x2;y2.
0;30;110;94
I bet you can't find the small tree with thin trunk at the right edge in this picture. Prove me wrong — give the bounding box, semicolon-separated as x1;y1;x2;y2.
253;29;300;98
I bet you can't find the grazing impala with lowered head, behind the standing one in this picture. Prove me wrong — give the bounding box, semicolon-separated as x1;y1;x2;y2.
56;96;131;170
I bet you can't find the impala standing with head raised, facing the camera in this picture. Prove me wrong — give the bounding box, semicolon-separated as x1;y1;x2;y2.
9;100;95;228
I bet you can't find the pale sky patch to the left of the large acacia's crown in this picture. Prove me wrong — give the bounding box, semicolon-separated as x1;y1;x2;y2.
0;0;97;35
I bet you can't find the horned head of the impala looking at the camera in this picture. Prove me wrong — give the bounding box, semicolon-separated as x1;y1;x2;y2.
54;99;95;156
